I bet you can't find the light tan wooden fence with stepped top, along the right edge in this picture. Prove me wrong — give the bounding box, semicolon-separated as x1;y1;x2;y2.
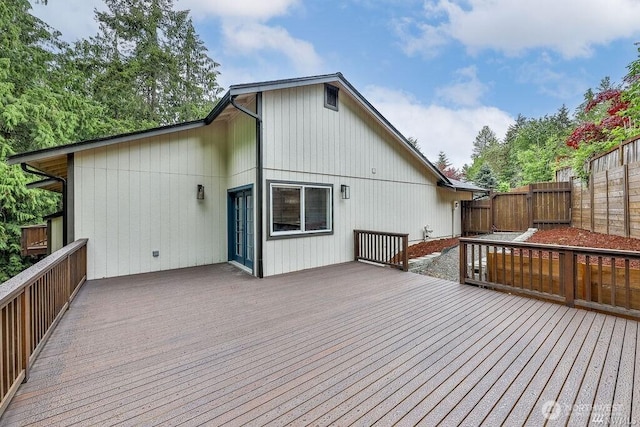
571;139;640;239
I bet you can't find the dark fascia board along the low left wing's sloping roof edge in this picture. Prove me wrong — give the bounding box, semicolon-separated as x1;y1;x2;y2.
7;120;205;165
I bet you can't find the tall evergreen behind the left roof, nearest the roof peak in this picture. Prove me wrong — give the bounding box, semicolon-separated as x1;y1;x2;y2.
75;0;221;128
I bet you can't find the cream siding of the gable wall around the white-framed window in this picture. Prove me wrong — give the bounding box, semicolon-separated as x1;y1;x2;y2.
263;85;468;275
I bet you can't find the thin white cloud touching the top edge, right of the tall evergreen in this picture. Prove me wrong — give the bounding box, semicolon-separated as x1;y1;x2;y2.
177;0;299;21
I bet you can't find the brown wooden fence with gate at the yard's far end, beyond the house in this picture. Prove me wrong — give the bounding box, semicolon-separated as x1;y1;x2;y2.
462;182;571;236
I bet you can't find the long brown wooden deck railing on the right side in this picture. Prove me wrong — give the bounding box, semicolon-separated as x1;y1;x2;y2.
460;238;640;318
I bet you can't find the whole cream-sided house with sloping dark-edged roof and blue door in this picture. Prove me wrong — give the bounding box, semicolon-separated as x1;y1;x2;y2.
9;73;477;279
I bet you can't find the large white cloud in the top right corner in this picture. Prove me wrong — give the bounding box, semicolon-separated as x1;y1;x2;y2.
396;0;640;58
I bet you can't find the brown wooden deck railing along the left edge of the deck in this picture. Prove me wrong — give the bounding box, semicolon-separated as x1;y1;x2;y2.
0;239;87;416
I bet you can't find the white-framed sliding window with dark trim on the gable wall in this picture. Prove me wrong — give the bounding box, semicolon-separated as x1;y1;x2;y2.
269;182;333;237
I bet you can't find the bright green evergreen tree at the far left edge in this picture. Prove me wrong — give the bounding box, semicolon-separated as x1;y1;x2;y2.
0;0;122;282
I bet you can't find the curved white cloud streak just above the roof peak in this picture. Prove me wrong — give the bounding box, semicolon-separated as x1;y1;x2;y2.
222;22;322;74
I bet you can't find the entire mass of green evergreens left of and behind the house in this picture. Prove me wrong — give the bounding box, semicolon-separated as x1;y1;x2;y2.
0;0;220;282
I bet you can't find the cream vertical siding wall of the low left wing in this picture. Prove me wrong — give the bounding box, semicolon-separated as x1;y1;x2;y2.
74;123;228;279
